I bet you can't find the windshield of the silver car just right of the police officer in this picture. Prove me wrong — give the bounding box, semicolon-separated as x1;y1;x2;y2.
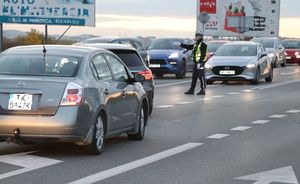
215;45;257;56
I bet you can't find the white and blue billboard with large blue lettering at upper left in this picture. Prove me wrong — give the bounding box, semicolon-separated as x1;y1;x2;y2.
0;0;95;26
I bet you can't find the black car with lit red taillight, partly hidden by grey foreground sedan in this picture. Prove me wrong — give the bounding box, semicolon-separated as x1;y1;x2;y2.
79;43;154;114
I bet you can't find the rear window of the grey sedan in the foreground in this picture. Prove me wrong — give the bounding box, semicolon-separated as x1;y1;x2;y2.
0;54;82;77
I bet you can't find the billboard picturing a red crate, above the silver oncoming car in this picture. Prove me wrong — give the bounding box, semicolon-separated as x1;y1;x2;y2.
197;0;280;37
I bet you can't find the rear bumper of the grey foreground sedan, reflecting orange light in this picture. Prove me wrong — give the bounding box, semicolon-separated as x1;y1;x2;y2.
0;106;92;142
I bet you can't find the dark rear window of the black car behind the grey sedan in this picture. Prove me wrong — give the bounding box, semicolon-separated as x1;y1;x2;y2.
111;50;144;67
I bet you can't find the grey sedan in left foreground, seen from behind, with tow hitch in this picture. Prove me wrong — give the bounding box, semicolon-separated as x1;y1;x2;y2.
0;45;149;154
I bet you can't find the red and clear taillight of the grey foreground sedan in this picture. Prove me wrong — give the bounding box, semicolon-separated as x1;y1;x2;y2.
60;82;83;106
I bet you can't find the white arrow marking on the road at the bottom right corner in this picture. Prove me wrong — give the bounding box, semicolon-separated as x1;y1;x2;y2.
235;166;299;184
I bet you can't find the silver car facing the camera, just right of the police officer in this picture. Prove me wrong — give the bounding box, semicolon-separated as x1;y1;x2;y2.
205;42;273;84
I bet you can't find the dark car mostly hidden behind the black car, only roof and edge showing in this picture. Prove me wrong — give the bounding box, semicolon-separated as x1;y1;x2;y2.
80;37;149;67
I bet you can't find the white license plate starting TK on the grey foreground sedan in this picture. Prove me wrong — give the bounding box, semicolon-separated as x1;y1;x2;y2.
8;94;32;111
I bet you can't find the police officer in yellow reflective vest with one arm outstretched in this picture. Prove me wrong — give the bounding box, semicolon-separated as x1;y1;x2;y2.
180;32;207;95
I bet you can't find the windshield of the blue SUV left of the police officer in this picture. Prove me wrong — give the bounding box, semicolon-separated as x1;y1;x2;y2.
148;39;183;50
